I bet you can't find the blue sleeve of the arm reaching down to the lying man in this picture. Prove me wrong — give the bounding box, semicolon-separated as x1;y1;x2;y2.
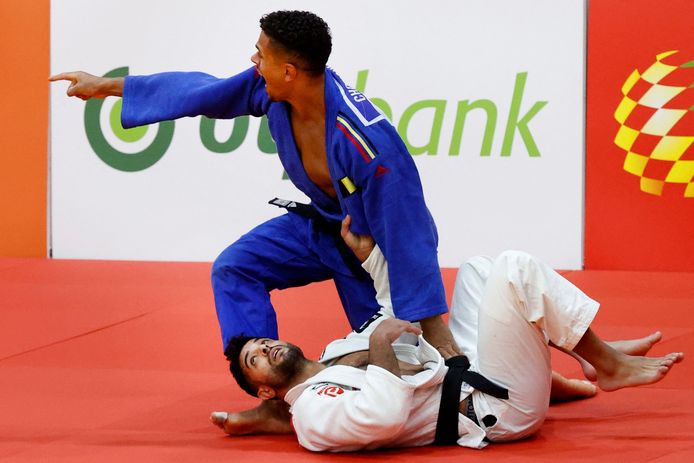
350;121;448;321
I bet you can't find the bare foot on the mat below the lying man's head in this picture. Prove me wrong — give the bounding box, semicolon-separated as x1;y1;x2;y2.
210;400;293;436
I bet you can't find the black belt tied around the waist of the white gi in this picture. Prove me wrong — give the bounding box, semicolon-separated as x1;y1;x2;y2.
434;355;508;445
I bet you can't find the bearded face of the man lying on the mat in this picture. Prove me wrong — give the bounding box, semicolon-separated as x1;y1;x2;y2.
239;338;306;389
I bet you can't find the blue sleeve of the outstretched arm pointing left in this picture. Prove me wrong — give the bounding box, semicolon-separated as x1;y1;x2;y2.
121;67;270;128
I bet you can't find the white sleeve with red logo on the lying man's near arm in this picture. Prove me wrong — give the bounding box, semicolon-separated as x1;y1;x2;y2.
291;365;415;452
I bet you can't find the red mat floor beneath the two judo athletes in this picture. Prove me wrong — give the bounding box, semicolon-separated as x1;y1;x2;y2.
0;259;694;463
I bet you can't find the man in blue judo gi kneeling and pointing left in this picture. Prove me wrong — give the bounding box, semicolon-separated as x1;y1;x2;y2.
51;11;457;357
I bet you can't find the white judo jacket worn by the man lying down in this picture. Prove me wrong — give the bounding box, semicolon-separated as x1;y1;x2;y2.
285;247;486;452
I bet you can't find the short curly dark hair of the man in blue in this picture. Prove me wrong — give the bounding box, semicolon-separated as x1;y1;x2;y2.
260;11;333;75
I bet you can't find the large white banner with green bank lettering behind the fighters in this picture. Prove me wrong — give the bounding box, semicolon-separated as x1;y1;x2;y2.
51;0;585;268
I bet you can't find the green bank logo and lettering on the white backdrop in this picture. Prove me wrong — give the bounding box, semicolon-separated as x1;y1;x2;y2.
84;67;547;172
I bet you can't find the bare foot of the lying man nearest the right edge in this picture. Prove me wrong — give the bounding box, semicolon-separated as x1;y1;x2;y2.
597;352;684;391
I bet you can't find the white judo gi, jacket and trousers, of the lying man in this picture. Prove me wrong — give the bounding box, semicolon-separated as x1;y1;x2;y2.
285;248;598;451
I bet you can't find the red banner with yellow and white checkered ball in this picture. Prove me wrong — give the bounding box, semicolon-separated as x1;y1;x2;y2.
585;0;694;271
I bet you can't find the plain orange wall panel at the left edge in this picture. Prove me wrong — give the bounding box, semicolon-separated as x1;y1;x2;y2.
0;0;50;257
